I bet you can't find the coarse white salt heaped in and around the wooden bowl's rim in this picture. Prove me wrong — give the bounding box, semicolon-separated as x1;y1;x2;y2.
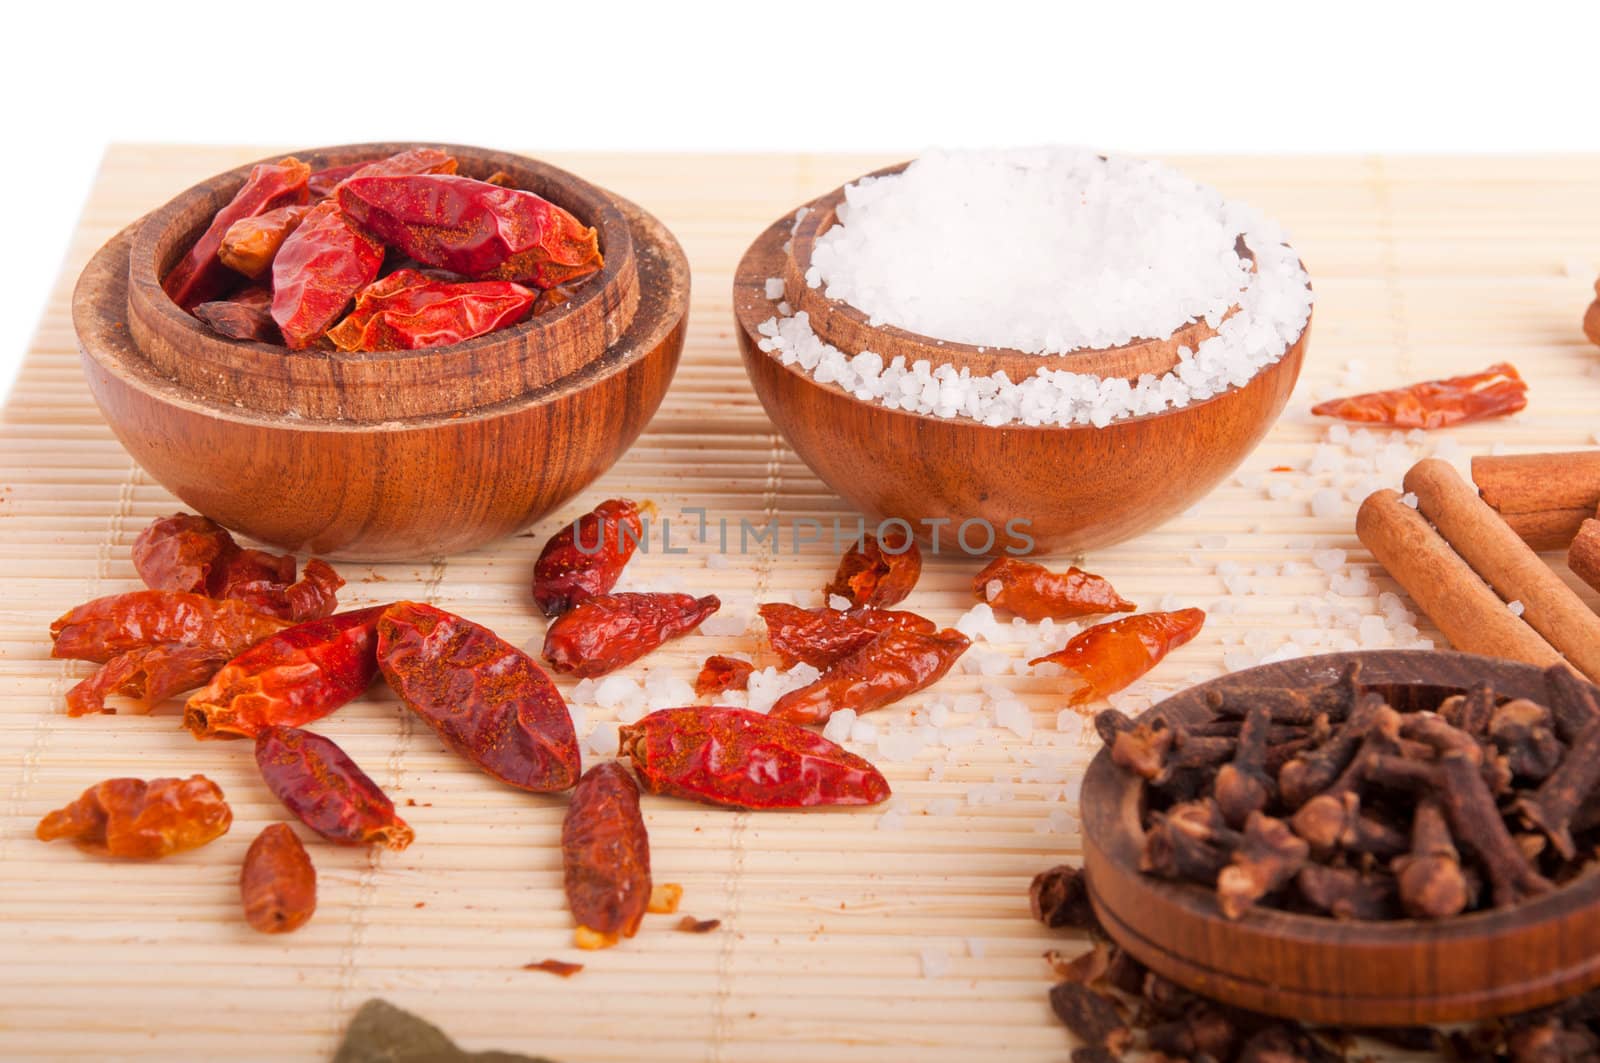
758;149;1312;427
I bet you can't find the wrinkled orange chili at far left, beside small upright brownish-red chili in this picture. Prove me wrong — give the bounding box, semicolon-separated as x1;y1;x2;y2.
34;775;234;860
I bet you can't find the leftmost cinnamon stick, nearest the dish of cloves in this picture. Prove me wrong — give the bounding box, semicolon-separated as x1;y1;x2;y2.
1355;488;1563;668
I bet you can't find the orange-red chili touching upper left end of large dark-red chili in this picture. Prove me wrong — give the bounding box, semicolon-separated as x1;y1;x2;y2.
184;605;384;738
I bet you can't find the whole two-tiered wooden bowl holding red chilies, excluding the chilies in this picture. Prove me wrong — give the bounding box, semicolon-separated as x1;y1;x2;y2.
72;144;690;560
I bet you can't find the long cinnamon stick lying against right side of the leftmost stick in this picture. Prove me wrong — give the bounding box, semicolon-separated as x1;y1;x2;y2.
1405;458;1600;680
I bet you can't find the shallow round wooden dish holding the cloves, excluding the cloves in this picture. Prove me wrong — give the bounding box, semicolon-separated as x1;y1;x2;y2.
1082;650;1600;1026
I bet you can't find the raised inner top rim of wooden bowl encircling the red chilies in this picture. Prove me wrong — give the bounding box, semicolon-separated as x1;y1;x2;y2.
128;141;637;419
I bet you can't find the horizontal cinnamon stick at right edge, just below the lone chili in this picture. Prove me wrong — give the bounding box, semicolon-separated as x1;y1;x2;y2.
1472;450;1600;551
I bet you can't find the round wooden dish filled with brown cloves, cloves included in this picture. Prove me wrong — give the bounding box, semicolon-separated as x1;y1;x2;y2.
1082;650;1600;1026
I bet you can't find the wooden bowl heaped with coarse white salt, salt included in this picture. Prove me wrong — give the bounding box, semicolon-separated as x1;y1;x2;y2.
733;149;1312;554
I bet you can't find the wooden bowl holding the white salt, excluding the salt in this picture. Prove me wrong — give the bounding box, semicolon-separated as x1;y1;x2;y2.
733;166;1310;554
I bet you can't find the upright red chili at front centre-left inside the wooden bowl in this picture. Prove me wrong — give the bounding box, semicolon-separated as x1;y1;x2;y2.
272;199;384;351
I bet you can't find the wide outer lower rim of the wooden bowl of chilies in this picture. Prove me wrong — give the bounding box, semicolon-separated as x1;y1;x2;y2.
70;186;691;435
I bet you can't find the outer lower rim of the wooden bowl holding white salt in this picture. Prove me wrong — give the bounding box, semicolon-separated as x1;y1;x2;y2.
733;200;1317;432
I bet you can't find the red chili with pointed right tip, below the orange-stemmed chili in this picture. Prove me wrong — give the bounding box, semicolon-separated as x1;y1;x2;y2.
544;594;722;679
